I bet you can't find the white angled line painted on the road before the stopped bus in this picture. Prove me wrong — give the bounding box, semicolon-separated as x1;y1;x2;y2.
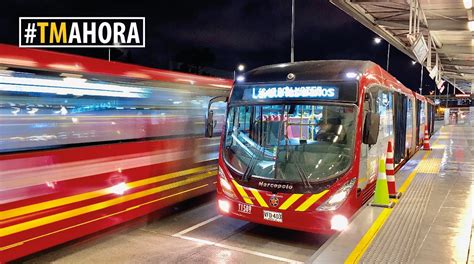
173;215;303;264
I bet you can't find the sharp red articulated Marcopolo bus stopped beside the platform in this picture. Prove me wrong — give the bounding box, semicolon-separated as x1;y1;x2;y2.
208;60;434;234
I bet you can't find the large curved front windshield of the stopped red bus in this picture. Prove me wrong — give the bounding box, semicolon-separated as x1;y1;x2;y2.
223;104;356;184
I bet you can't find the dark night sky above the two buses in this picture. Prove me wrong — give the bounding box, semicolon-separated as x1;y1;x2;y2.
0;0;435;93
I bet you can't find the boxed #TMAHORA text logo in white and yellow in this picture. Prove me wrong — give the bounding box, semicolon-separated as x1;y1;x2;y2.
19;17;145;48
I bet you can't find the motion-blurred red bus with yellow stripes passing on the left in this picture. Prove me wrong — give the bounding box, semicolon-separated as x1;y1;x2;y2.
0;45;232;262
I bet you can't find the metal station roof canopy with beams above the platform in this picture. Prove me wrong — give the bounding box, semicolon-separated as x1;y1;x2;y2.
331;0;474;93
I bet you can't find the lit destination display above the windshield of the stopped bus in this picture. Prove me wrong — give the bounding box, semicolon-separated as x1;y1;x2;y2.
243;85;339;100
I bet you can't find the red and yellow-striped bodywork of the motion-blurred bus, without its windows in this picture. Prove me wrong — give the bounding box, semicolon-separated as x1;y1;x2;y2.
0;45;232;262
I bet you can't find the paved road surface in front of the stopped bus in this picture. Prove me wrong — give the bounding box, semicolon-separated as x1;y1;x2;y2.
19;194;329;263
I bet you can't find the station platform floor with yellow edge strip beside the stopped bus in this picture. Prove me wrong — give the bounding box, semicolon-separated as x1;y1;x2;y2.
308;124;474;263
